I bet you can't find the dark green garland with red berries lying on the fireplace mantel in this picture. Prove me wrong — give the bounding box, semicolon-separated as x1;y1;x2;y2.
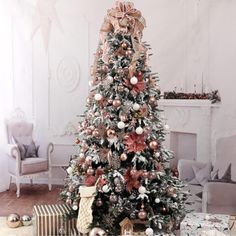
164;90;221;103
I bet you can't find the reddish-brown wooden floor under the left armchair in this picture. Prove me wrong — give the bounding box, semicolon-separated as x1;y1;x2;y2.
0;184;62;216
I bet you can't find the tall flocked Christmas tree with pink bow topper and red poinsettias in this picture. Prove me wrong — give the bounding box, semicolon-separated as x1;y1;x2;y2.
61;2;187;235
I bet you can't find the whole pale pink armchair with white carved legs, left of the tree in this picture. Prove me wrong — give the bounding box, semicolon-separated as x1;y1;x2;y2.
6;111;54;197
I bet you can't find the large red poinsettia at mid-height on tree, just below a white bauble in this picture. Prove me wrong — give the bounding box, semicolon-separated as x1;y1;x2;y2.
124;132;146;153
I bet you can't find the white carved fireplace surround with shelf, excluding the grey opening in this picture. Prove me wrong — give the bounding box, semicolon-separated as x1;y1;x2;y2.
158;99;220;162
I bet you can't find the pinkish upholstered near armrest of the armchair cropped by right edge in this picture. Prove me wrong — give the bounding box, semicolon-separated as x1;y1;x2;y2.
202;182;236;212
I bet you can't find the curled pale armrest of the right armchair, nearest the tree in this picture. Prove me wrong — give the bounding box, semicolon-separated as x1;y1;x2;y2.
177;159;205;182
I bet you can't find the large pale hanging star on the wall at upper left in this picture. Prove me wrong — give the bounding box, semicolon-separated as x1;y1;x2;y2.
31;0;62;52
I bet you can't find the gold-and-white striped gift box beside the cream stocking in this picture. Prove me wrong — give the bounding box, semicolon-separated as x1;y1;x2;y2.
33;204;77;236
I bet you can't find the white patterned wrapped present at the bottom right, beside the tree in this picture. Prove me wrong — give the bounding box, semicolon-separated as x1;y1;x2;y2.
180;213;230;236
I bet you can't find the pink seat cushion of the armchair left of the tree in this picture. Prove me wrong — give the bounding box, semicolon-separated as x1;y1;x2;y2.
21;157;48;174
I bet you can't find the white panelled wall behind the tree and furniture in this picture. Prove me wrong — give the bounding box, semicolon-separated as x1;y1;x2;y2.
0;0;236;190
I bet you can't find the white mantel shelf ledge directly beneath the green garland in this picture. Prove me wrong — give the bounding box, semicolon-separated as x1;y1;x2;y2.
158;99;220;108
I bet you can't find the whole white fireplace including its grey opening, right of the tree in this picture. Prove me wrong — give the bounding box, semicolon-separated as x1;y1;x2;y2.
159;99;219;162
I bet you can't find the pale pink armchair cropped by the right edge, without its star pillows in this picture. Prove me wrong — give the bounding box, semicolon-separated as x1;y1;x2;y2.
178;135;236;215
